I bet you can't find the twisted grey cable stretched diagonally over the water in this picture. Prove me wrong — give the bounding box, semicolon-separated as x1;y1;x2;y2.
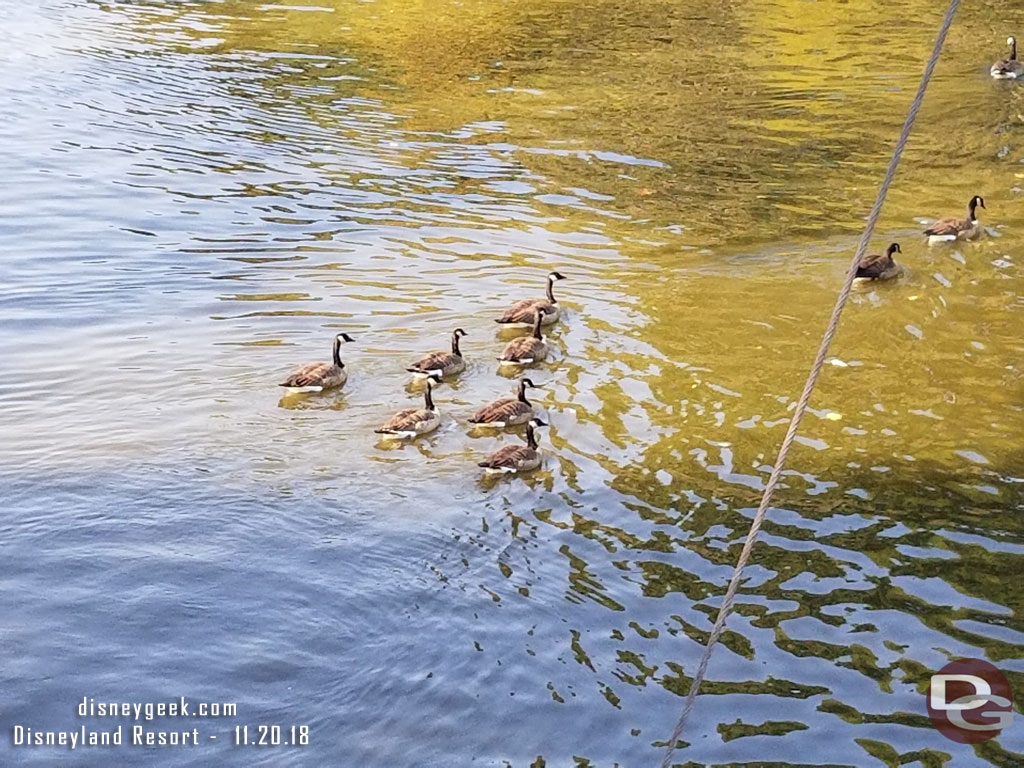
662;0;959;768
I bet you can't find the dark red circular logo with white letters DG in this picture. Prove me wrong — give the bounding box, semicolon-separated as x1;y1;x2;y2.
928;658;1014;744
